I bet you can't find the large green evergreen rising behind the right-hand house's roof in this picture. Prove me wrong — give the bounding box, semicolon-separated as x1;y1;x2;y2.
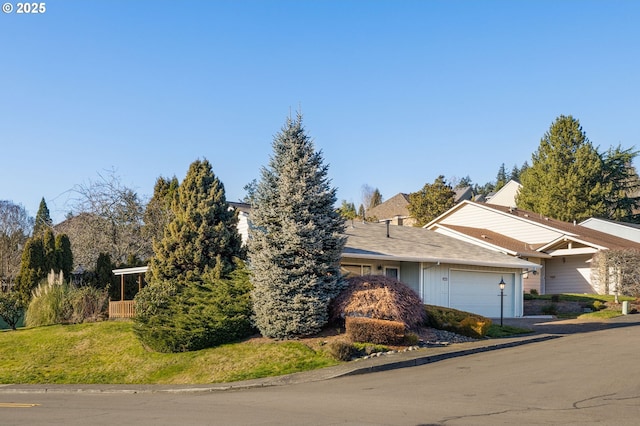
516;116;613;221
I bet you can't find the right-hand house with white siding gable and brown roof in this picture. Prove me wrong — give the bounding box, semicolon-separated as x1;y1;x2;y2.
425;201;640;294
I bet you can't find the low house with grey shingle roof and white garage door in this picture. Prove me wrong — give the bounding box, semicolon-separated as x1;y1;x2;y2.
341;222;539;318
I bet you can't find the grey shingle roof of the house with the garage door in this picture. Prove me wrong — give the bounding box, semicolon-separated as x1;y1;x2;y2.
342;222;539;269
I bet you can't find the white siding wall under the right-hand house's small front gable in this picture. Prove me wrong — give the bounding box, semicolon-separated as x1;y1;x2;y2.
544;255;596;294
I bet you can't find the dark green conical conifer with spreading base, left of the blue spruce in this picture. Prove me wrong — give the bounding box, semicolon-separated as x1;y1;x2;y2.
134;160;251;352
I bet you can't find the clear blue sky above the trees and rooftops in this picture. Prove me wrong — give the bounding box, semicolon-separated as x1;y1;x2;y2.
0;0;640;222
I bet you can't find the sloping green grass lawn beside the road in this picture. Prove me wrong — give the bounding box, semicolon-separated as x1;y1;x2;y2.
0;321;338;384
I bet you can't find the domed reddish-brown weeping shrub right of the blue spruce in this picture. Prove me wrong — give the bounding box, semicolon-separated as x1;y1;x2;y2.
330;275;425;329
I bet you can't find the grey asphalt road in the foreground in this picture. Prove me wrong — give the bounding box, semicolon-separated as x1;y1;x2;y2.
0;326;640;425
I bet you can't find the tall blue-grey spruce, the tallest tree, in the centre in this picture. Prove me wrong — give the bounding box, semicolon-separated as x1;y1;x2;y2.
249;114;345;338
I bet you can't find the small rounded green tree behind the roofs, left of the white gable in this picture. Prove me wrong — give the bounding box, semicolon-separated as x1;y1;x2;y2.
407;175;456;226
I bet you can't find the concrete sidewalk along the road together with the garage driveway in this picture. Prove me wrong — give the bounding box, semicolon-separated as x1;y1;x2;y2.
0;315;640;394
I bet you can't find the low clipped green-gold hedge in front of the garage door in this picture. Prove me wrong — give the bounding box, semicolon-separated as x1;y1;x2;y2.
424;305;492;338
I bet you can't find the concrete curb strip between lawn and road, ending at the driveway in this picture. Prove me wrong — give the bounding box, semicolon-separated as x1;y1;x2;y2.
0;334;562;394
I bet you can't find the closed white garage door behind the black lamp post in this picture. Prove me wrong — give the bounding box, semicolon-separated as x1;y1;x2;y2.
449;270;515;318
